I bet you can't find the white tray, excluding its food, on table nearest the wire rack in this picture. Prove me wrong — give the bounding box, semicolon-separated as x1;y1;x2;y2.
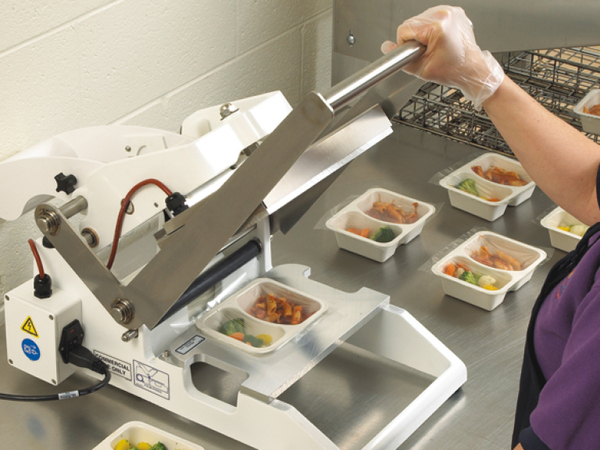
440;153;535;222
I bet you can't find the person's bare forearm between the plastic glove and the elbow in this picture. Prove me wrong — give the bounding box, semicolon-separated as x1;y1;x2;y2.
483;77;600;225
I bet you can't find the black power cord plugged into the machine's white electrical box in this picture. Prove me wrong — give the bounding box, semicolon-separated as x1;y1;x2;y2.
0;345;110;402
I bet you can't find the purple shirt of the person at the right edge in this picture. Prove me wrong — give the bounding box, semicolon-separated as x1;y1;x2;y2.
531;279;600;450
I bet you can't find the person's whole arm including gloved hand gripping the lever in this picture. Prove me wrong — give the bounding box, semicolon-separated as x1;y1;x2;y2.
382;6;600;225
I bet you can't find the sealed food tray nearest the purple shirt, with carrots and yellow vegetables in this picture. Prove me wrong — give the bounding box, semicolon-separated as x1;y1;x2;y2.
432;231;546;311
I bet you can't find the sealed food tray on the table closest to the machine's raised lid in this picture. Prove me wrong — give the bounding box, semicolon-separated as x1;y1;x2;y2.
326;188;435;262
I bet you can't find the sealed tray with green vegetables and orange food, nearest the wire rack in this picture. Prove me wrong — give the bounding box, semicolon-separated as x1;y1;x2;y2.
439;153;535;222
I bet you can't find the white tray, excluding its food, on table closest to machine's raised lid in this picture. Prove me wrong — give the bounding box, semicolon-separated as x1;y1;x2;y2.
326;188;435;262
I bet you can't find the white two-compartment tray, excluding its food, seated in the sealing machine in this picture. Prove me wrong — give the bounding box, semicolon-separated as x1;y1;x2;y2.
196;278;327;355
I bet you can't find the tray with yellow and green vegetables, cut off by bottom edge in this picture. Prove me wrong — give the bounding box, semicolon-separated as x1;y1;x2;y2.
93;421;204;450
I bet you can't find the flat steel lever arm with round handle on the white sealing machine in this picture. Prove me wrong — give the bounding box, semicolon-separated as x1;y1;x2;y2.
38;42;424;330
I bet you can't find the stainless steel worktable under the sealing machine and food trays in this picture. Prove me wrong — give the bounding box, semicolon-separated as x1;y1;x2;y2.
0;125;564;450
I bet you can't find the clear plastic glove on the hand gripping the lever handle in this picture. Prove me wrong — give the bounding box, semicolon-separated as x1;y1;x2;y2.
381;6;504;110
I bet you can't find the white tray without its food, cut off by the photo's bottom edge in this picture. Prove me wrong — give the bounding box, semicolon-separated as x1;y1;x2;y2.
93;421;204;450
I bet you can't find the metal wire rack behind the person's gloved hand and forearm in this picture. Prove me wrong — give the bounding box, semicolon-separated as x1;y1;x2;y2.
393;47;600;155
